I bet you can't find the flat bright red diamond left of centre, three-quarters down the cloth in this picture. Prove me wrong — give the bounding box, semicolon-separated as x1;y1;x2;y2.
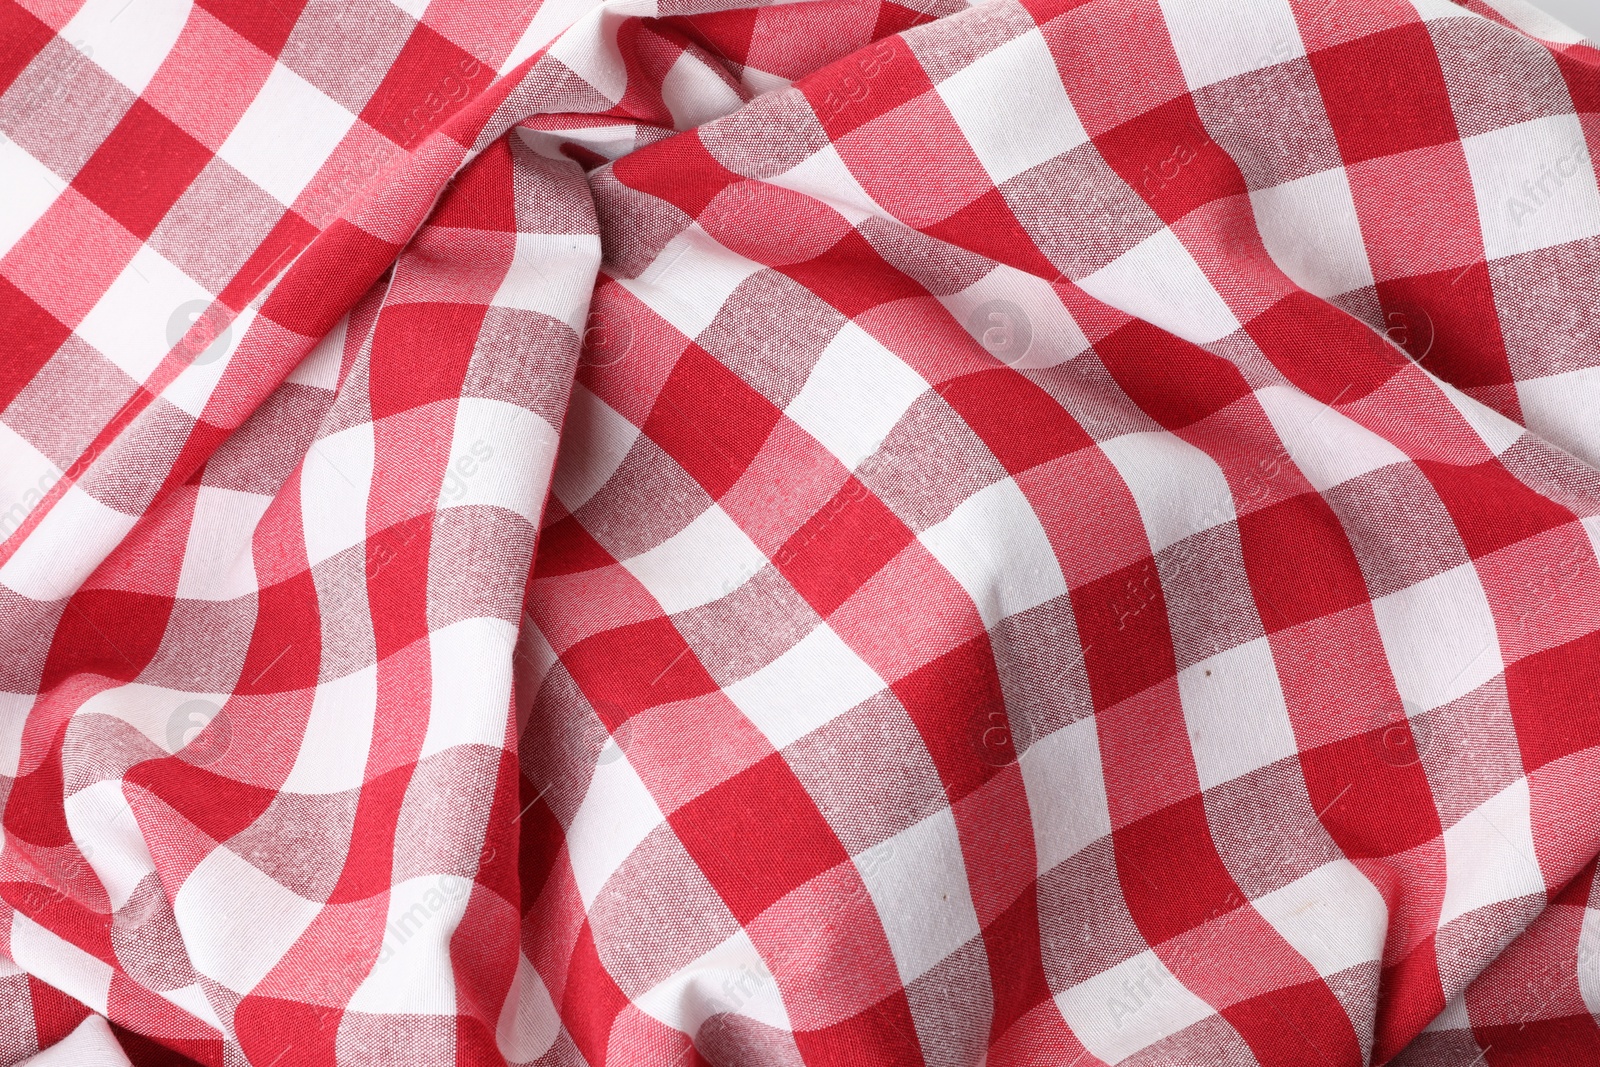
670;752;850;925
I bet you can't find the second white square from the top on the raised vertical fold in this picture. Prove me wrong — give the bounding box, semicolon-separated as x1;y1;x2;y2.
438;397;558;528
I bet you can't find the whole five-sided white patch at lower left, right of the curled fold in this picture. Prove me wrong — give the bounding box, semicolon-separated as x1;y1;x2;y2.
173;845;322;993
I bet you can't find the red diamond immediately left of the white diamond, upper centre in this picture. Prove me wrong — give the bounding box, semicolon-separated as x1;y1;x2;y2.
645;344;782;499
